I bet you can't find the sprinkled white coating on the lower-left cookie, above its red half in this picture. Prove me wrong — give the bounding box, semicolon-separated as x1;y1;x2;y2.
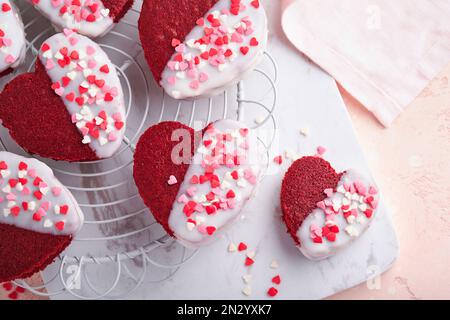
0;151;84;235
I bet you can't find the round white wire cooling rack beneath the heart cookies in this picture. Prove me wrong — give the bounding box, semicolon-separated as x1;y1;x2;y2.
0;1;277;299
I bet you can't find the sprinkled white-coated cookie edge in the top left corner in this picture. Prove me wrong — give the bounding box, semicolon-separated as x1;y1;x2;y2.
0;0;26;73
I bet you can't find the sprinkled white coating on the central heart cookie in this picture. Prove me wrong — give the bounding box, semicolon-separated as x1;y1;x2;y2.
168;120;261;247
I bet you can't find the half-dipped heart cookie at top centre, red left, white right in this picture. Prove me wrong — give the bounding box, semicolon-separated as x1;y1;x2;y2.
139;0;268;99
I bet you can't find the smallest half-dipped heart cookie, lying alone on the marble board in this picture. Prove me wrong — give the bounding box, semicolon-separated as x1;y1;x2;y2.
281;157;379;260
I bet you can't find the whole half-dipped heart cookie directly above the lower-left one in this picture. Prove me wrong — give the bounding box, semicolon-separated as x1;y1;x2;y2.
0;30;125;161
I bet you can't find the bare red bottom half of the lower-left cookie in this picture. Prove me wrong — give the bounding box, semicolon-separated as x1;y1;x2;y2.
0;224;72;283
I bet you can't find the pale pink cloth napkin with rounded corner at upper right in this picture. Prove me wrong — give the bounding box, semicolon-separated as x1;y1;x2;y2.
282;0;450;126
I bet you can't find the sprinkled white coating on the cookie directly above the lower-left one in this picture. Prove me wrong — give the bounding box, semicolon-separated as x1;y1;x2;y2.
39;29;125;158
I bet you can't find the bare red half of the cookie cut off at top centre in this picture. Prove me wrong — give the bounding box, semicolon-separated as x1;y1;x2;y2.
139;0;218;84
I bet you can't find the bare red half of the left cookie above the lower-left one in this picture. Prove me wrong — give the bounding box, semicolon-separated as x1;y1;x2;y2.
0;60;97;161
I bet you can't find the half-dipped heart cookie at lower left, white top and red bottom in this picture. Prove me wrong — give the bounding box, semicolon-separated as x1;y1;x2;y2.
0;152;83;283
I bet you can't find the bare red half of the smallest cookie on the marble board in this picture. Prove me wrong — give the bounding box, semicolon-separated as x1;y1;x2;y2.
281;157;342;245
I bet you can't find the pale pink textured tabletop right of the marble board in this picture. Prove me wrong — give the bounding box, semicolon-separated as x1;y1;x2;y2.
333;65;450;299
